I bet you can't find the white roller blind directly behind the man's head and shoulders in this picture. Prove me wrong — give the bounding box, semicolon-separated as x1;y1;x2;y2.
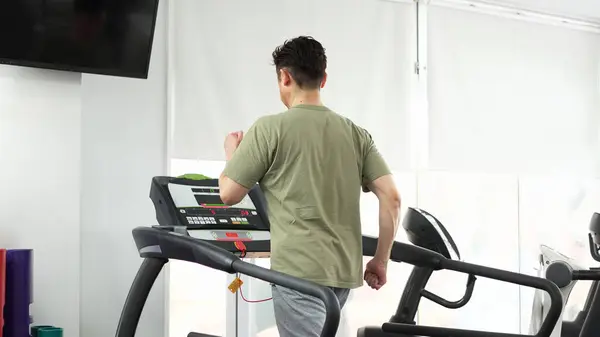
173;0;416;169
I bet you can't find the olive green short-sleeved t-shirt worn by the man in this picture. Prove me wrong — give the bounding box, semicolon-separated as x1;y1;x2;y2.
223;105;390;289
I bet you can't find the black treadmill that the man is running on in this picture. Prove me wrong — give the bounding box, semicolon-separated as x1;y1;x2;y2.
115;177;340;337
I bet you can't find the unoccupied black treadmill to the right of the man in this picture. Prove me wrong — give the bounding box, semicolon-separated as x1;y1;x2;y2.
358;208;563;337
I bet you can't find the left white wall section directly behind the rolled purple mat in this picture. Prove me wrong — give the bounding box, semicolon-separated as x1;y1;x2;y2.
0;66;81;337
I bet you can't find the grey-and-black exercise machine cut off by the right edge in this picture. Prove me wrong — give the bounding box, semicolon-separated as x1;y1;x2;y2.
529;213;600;337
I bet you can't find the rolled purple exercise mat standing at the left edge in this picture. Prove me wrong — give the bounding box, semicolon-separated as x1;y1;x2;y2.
3;249;33;337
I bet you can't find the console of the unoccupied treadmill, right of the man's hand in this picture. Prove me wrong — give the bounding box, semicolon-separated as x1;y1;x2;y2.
402;208;460;260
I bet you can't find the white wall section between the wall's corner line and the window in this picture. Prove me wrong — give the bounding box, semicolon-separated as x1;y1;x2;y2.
80;1;167;337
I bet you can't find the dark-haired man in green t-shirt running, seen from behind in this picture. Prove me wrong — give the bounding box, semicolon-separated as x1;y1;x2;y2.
219;36;400;337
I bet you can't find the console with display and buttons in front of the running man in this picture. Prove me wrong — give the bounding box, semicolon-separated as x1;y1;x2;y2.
150;177;269;231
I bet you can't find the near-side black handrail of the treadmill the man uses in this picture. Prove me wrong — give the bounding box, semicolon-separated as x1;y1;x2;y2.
132;227;340;337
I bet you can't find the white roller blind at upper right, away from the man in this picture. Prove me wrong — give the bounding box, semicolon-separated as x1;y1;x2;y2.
428;6;600;174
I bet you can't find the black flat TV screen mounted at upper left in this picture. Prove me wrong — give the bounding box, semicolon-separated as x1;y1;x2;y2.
0;0;158;78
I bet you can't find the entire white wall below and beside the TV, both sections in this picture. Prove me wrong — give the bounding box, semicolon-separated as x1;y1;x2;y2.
0;2;166;337
